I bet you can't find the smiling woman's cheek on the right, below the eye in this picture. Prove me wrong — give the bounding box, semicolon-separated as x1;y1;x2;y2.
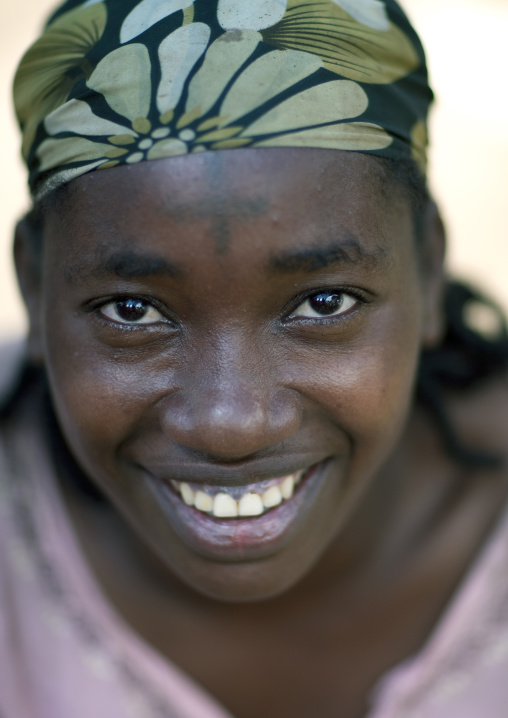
296;308;421;472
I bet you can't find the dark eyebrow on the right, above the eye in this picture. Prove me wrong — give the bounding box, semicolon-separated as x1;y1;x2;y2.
269;233;389;273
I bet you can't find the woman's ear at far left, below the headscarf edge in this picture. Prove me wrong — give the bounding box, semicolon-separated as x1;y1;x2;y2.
14;218;43;364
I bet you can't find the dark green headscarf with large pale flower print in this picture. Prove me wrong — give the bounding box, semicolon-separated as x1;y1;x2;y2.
14;0;432;197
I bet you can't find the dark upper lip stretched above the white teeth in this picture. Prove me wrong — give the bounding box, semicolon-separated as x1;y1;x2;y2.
141;455;328;486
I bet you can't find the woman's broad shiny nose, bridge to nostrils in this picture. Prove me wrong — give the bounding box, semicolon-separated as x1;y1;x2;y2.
161;338;302;461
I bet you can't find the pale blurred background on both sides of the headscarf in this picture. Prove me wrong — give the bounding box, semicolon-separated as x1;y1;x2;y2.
0;0;508;338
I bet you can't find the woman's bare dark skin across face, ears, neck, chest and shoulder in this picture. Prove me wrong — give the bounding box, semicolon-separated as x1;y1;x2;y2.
13;149;507;718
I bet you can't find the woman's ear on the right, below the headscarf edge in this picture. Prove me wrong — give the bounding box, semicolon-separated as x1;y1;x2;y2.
421;201;447;349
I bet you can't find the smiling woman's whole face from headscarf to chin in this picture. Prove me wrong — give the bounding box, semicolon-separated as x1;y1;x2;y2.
21;149;437;600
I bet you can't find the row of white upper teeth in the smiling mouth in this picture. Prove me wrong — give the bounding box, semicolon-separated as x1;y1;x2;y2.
171;470;304;518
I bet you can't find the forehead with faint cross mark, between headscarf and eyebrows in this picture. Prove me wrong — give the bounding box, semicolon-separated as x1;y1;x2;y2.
41;148;412;272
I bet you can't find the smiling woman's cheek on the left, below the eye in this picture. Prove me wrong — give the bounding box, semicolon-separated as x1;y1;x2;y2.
43;278;166;463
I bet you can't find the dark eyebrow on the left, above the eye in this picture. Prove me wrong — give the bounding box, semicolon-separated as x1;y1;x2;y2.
68;250;183;281
